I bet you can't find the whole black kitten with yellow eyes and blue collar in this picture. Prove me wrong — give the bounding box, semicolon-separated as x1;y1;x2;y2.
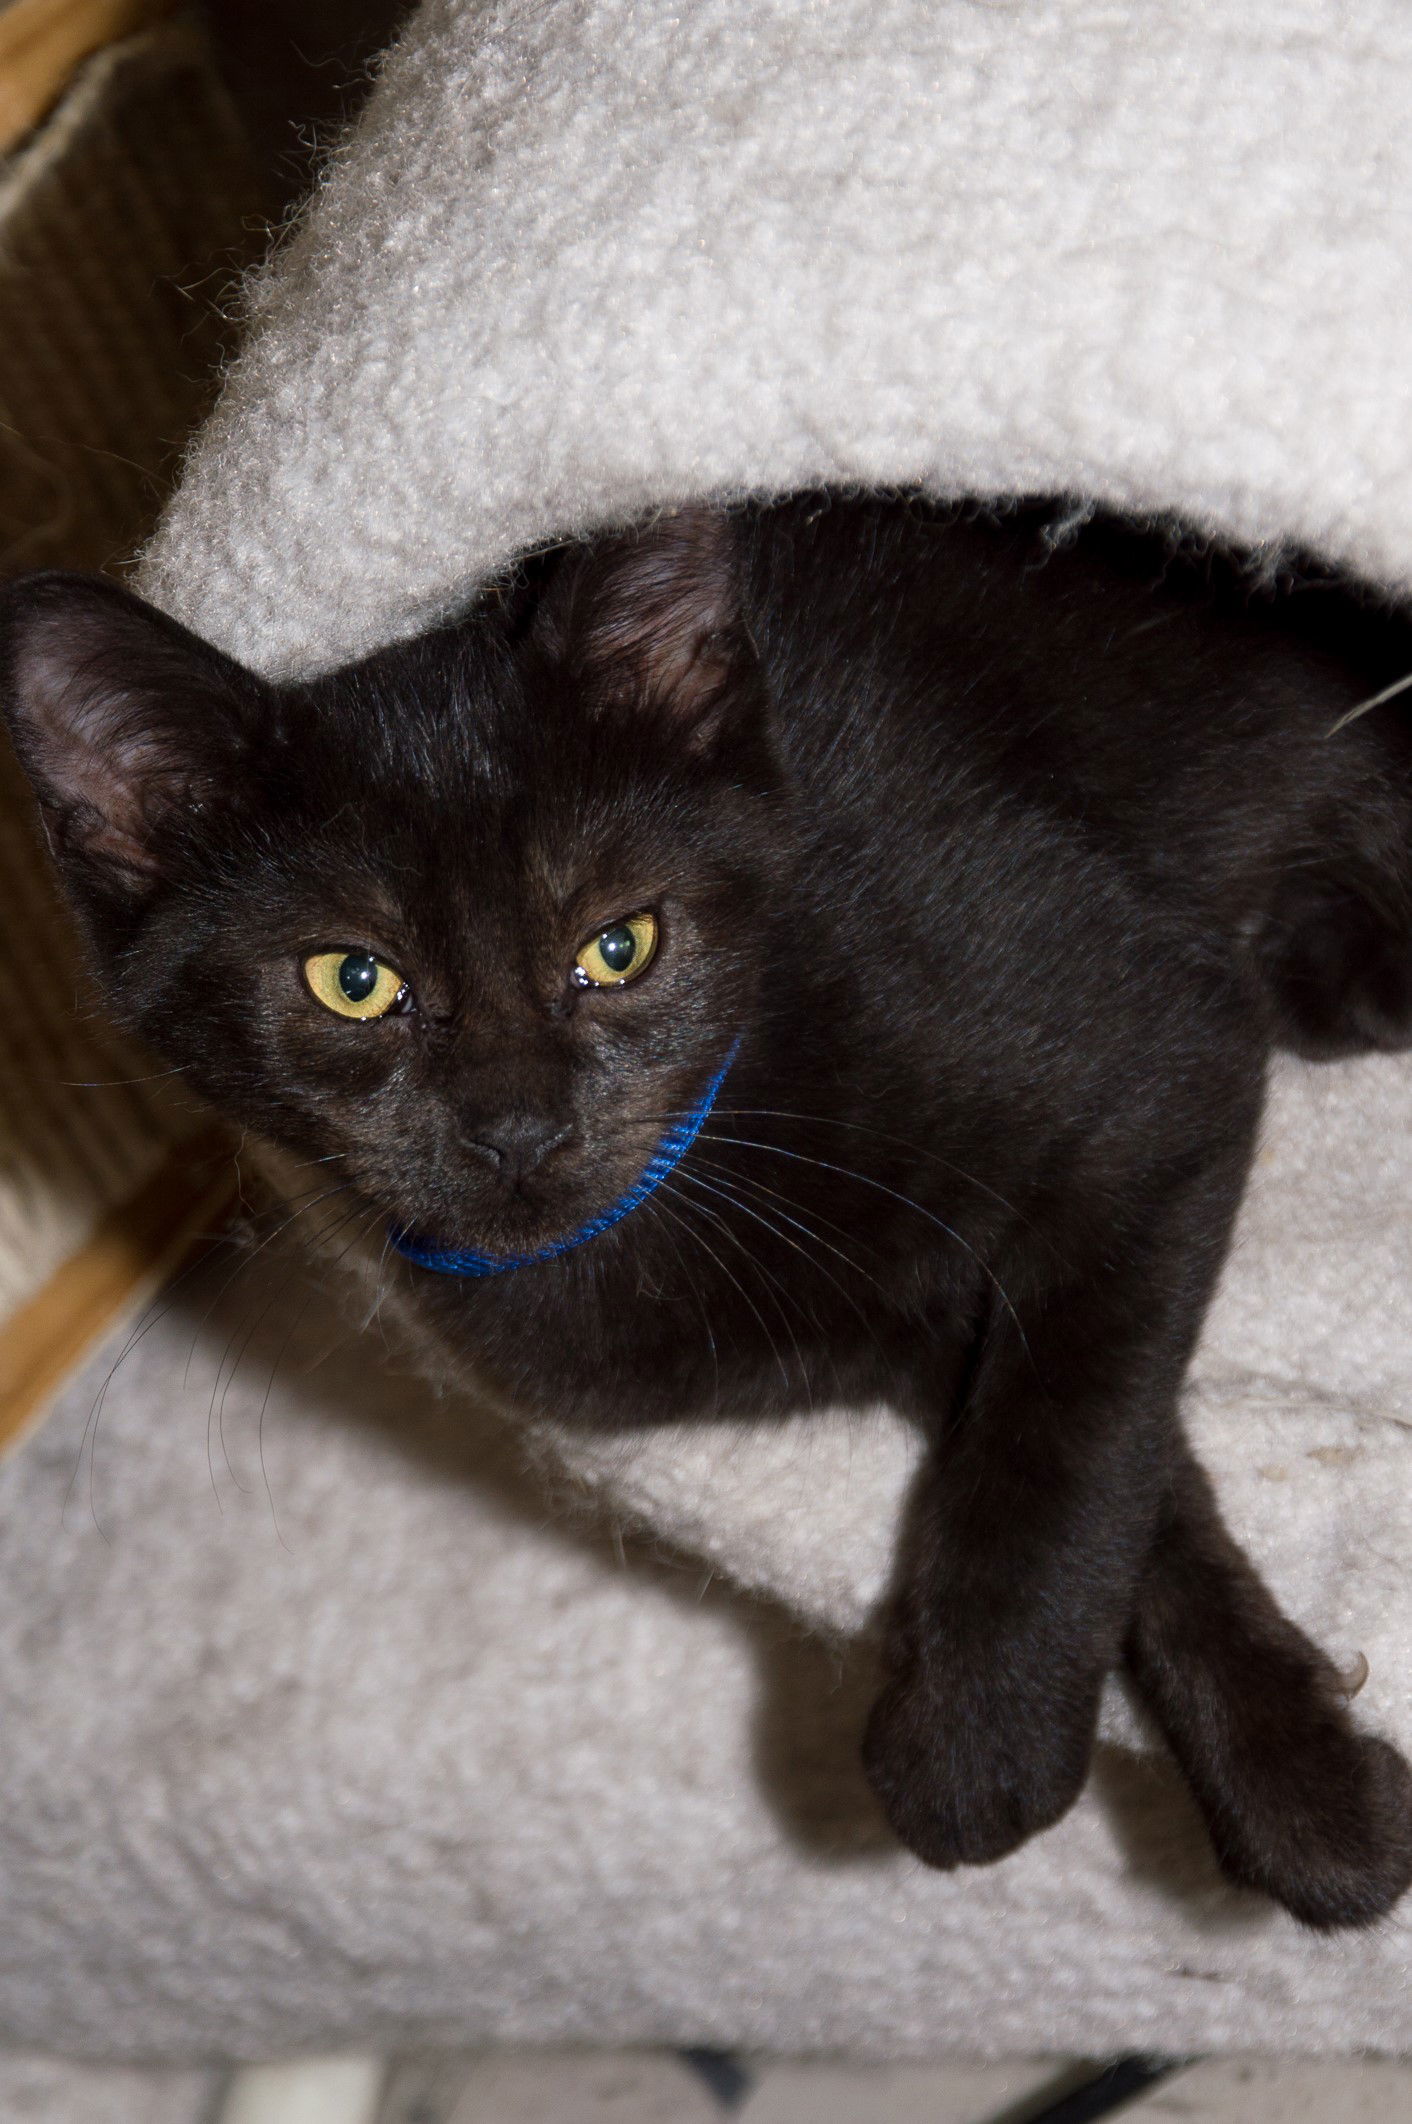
0;497;1412;1926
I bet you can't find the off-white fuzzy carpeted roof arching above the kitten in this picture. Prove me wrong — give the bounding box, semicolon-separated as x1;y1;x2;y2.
147;0;1412;669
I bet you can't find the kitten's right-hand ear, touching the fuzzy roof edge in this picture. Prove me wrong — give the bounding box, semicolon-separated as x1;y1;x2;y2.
531;508;758;752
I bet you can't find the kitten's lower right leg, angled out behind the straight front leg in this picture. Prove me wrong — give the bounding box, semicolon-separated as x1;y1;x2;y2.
1125;1440;1412;1926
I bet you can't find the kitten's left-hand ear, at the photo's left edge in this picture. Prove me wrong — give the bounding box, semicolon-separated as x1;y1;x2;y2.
0;573;257;903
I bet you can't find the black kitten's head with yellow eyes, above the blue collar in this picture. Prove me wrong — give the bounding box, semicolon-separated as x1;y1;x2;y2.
0;512;788;1253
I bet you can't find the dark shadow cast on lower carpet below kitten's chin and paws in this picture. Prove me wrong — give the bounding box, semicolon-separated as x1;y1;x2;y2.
121;1223;1274;1928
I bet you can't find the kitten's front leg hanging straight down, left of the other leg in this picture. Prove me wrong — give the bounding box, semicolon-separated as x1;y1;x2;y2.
864;1129;1255;1867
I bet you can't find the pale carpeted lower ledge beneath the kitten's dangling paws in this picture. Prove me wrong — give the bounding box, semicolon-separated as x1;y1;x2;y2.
0;1253;1412;2062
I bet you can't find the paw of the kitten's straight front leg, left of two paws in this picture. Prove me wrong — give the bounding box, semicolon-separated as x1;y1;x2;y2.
862;1676;1098;1869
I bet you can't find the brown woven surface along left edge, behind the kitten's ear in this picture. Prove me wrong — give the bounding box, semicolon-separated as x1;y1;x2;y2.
0;17;263;1442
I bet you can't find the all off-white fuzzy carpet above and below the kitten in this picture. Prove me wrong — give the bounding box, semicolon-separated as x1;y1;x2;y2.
13;0;1412;2056
